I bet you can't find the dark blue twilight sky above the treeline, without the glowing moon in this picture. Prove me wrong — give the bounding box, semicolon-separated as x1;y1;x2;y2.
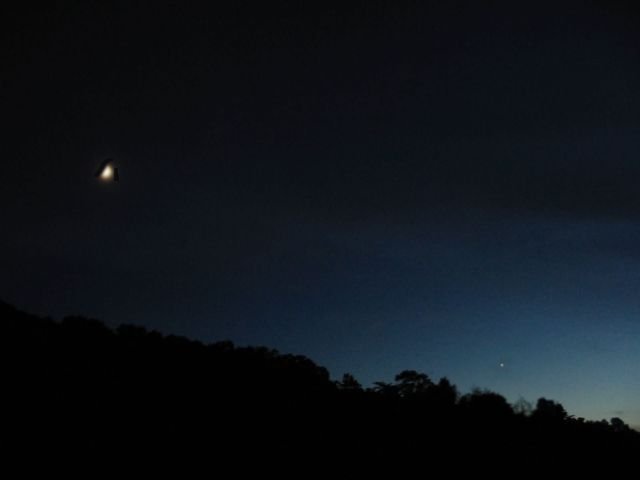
0;0;640;427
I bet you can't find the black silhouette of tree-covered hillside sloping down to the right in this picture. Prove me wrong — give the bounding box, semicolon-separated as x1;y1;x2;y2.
0;303;640;462
